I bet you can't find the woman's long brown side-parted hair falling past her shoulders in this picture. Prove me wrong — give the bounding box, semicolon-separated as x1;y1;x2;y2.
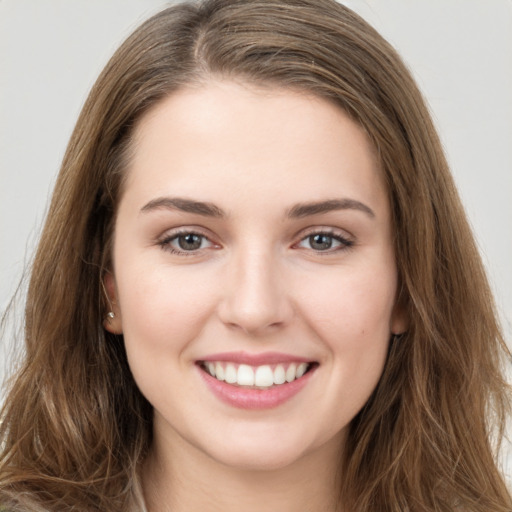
0;0;512;512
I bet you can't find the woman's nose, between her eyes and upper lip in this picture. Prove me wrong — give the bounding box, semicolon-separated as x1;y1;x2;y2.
219;246;293;335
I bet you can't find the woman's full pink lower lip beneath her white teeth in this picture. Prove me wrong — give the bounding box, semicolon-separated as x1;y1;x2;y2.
198;366;316;410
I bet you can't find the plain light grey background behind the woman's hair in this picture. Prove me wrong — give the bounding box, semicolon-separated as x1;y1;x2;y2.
0;0;512;473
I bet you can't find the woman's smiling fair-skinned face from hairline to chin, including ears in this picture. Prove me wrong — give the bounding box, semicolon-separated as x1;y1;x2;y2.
106;82;404;468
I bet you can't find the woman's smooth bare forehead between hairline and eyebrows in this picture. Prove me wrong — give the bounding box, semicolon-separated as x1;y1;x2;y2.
122;81;386;218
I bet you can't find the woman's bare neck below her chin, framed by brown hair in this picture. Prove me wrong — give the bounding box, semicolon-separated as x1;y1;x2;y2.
142;430;342;512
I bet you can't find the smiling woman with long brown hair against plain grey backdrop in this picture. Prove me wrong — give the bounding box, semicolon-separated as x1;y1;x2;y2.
0;0;512;512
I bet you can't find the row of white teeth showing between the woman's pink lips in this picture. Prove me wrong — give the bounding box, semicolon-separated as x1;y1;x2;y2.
198;361;318;390
